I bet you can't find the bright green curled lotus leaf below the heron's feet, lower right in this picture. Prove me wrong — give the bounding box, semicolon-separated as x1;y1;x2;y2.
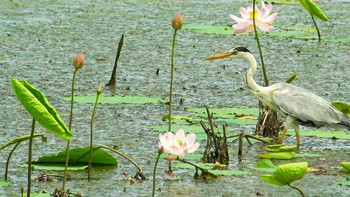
260;162;308;186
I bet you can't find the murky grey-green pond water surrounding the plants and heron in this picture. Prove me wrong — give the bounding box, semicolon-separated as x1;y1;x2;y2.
0;0;350;196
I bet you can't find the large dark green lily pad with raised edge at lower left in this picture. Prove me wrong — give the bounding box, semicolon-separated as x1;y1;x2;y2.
27;147;118;170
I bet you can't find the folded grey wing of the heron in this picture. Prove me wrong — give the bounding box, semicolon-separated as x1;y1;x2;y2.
272;83;341;124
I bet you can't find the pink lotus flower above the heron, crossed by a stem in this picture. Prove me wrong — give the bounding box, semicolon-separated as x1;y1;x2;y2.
230;1;278;33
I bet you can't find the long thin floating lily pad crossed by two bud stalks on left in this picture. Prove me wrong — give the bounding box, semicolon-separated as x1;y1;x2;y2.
63;95;167;104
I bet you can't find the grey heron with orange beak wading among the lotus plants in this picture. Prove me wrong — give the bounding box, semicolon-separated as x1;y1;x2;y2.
206;47;350;146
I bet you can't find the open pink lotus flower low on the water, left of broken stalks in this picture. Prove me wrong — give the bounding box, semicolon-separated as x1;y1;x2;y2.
158;129;199;160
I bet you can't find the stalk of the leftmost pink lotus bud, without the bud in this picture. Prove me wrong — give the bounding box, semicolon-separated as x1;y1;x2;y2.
62;68;78;196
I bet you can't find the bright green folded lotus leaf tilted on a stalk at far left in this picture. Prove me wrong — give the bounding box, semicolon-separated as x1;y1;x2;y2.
11;78;72;140
